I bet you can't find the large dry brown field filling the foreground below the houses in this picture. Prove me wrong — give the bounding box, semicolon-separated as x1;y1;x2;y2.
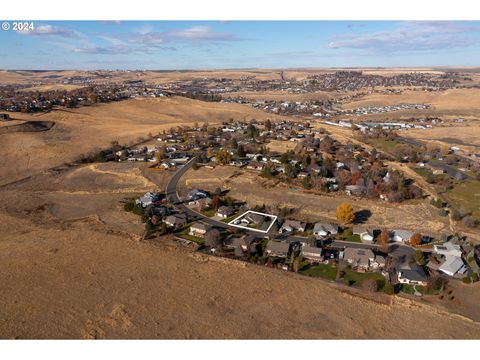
0;163;480;339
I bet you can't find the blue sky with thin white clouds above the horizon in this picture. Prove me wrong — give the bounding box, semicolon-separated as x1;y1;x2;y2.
0;21;480;70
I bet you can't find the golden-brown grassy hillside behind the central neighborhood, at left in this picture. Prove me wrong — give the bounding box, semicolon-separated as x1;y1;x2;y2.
0;97;284;185
